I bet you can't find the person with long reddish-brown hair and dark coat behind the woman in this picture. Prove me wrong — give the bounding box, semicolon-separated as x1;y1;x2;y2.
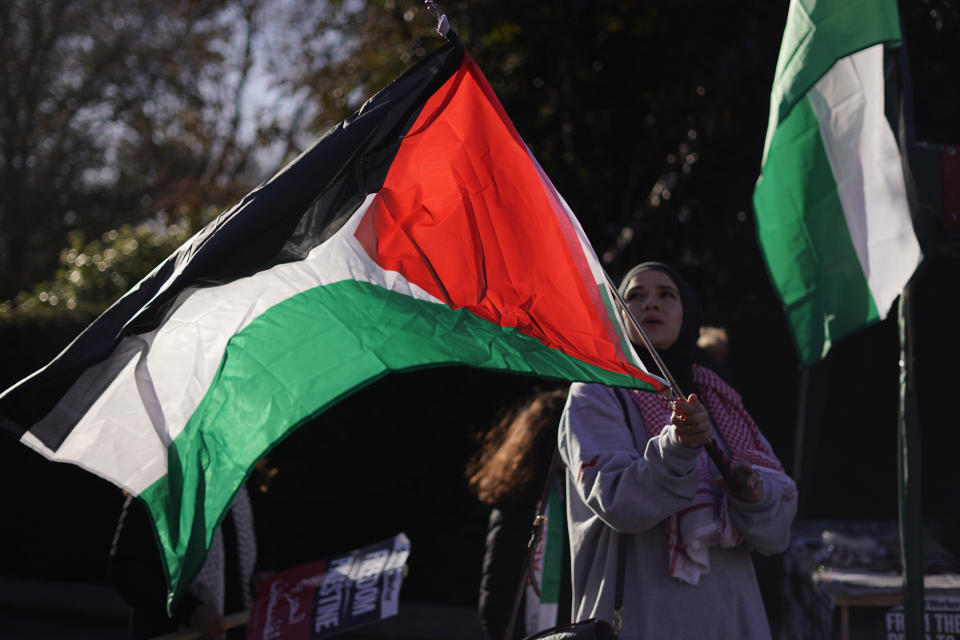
467;388;570;640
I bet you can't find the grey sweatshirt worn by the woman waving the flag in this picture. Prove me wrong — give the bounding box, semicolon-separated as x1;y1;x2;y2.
559;383;797;640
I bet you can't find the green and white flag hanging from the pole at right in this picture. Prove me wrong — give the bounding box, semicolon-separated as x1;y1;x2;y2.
753;0;921;365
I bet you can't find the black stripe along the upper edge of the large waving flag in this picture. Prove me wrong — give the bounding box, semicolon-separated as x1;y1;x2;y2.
0;38;463;442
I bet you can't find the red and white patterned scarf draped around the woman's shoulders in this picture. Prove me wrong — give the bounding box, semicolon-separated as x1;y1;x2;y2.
628;365;783;584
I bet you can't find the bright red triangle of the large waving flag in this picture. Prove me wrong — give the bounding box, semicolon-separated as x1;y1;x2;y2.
356;55;646;378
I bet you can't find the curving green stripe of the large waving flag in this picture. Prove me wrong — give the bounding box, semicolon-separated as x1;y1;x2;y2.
141;281;650;595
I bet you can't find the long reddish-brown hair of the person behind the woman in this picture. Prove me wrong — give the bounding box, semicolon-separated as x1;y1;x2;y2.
467;387;567;507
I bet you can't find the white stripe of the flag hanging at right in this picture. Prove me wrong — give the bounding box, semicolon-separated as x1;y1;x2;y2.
808;45;920;317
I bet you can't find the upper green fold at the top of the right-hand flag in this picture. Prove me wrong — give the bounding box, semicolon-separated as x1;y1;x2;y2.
764;0;900;159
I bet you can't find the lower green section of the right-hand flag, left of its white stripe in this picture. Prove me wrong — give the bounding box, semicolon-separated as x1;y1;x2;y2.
753;94;880;364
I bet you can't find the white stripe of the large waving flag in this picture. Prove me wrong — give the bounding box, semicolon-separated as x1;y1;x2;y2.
21;194;441;494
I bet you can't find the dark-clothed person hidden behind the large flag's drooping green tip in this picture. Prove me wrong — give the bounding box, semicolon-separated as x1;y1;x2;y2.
109;485;257;640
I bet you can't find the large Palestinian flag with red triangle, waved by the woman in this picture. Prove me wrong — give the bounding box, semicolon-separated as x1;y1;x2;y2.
0;36;662;598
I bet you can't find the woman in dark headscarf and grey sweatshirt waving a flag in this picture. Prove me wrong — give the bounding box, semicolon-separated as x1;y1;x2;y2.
559;262;797;640
